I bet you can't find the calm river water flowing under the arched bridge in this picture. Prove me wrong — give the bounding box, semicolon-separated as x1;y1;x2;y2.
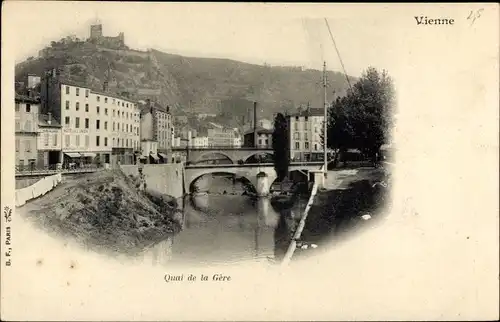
139;176;308;266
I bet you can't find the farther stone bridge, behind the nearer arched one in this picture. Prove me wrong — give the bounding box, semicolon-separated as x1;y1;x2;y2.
172;147;273;164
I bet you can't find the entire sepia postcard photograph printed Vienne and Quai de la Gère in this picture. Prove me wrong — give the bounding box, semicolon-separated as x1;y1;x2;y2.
2;1;498;321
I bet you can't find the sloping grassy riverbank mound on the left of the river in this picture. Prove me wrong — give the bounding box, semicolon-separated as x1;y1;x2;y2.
18;170;184;255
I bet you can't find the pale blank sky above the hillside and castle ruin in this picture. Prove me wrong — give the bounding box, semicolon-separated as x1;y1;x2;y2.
3;1;406;76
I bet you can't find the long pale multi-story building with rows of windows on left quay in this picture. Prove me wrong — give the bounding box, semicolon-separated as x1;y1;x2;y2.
41;71;140;165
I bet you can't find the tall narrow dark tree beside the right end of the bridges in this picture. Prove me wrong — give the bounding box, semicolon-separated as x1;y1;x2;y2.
272;113;290;189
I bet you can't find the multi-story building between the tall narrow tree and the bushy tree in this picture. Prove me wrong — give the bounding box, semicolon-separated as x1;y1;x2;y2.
287;108;325;161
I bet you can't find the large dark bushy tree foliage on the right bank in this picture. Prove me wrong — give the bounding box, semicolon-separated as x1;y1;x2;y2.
327;67;394;160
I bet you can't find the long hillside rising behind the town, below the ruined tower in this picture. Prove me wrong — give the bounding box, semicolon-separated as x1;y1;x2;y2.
16;41;356;118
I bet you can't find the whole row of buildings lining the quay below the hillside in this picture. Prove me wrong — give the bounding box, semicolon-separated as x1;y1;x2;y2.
15;70;324;168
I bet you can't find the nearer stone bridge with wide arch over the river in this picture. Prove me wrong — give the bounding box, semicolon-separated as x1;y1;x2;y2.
184;162;323;197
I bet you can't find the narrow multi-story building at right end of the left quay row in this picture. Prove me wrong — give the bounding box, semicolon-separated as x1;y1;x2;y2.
140;100;173;161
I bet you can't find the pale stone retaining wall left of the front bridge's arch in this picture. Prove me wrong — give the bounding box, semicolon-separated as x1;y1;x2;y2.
120;163;184;198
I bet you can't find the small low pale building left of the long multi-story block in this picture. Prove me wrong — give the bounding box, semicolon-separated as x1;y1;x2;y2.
37;113;63;169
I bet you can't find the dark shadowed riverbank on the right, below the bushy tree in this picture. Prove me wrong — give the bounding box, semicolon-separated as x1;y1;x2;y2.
294;167;389;257
